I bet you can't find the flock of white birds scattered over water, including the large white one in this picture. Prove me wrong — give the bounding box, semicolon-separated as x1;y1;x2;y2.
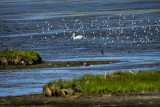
37;14;160;45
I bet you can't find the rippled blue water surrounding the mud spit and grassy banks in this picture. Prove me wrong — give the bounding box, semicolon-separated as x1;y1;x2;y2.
0;0;160;96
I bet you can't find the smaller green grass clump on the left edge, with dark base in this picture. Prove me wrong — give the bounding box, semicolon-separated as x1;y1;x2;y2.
0;49;42;66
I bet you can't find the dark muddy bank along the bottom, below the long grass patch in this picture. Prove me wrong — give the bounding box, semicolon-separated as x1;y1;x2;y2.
0;92;160;107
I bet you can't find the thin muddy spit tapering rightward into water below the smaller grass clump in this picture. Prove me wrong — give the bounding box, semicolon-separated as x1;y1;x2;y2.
0;61;120;70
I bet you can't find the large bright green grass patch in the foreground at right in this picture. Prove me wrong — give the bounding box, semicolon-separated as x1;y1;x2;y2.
43;70;160;96
